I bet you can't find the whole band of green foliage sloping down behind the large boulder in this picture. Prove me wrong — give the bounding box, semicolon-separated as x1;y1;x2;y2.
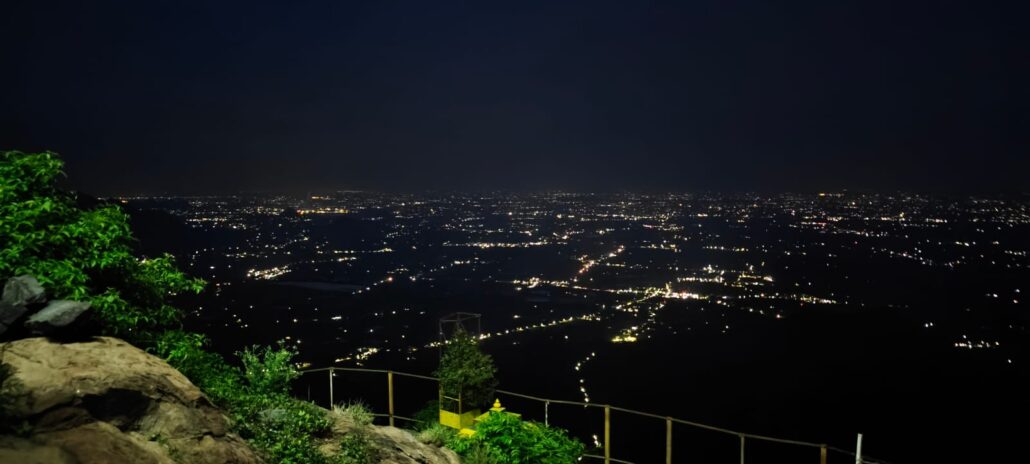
0;152;341;464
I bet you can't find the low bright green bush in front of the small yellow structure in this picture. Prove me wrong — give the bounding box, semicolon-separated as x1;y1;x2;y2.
447;412;583;464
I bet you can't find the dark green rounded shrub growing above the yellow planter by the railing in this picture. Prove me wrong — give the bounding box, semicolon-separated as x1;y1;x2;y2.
435;328;497;410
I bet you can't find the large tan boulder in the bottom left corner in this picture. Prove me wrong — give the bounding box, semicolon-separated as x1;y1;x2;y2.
0;337;261;464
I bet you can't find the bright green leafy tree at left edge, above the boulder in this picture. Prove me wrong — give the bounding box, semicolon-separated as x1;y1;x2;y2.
0;152;204;343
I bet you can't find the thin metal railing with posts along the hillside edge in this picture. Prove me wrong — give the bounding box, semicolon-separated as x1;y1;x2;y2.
301;367;887;464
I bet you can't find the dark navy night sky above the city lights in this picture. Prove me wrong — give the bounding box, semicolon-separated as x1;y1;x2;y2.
0;0;1030;195
